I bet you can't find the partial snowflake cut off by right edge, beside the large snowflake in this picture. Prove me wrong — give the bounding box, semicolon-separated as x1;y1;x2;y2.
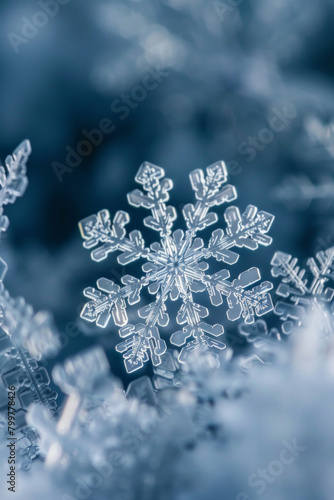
271;247;334;335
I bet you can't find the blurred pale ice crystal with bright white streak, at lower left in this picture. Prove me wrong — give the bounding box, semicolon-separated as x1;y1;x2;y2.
28;347;124;469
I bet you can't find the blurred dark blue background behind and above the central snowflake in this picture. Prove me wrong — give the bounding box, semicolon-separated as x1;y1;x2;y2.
0;0;334;384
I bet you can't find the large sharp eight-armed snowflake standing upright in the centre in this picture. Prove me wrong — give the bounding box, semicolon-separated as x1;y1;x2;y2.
79;162;274;372
